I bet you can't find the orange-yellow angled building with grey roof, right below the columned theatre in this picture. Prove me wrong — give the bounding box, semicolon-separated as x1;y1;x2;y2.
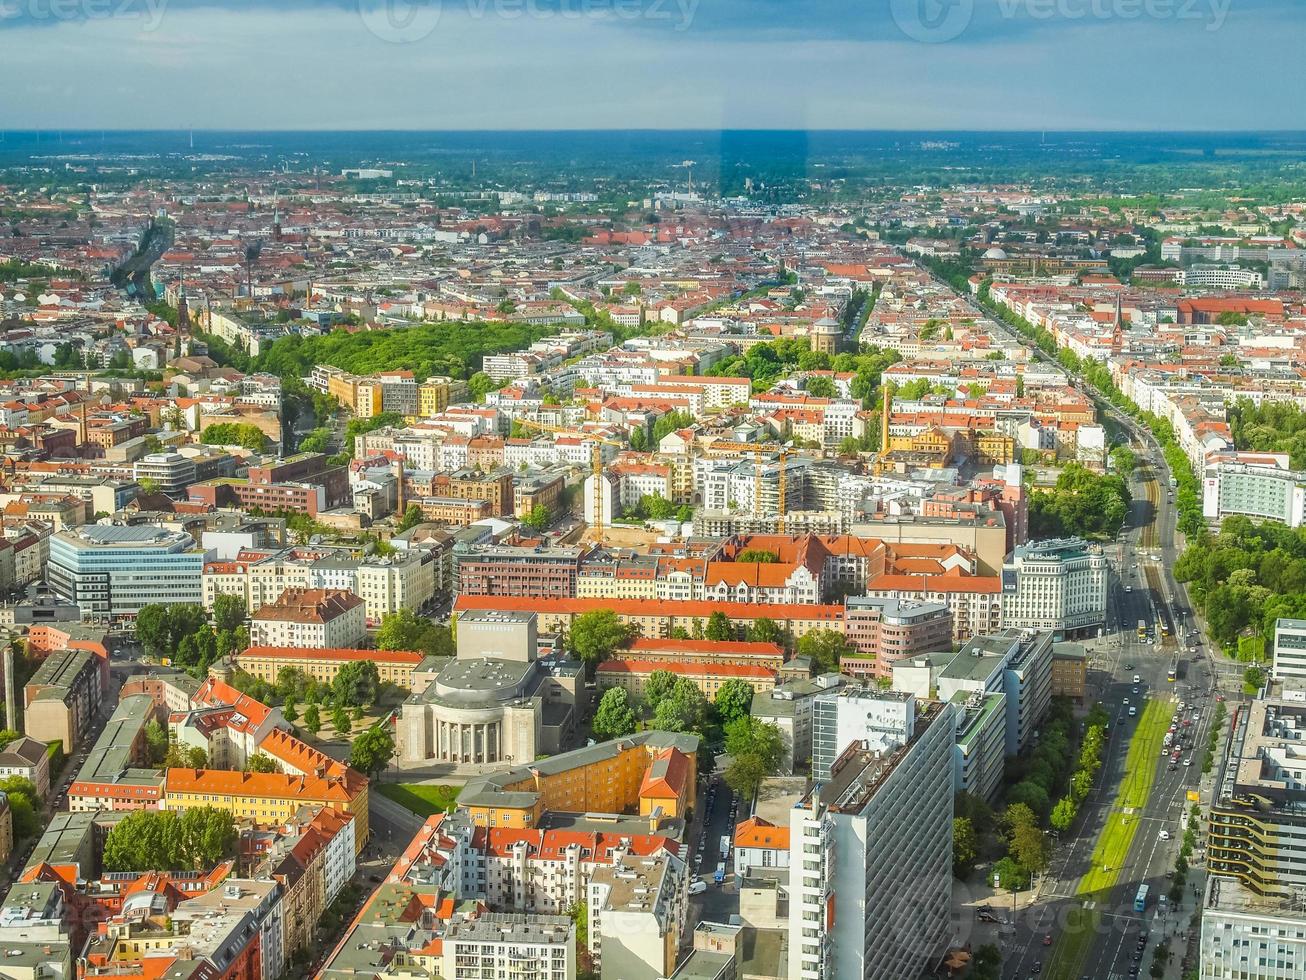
458;732;699;828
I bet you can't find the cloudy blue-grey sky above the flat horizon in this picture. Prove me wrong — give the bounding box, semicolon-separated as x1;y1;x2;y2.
0;0;1306;131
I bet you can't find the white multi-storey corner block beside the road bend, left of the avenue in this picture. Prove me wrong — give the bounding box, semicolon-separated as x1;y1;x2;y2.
1002;538;1107;640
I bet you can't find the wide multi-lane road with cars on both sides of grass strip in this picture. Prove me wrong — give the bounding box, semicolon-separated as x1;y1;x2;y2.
1004;446;1213;980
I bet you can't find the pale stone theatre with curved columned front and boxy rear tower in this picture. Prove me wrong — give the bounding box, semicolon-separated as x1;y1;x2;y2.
398;612;585;766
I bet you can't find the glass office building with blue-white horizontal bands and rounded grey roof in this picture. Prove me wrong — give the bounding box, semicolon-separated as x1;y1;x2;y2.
48;524;210;618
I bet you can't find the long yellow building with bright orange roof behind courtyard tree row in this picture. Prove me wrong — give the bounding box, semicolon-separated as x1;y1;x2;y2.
159;766;368;852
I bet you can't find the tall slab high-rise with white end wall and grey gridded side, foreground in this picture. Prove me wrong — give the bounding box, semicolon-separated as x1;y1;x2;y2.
789;702;955;980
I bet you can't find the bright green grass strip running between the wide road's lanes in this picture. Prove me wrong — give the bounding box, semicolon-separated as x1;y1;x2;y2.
1047;699;1171;980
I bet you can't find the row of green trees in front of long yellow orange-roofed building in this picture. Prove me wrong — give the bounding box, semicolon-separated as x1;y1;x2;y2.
103;806;236;872
